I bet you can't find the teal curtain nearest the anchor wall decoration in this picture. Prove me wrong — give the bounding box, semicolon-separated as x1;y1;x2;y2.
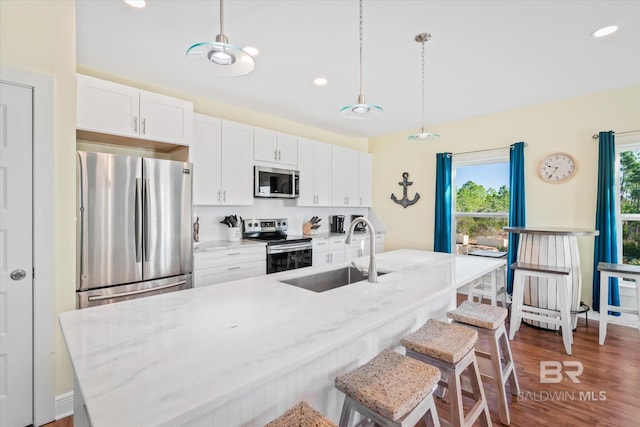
433;153;451;253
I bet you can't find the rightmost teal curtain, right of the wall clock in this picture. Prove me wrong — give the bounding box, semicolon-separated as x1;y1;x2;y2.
591;131;620;316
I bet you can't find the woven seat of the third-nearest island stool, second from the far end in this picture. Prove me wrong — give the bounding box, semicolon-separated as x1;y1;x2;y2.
402;319;478;363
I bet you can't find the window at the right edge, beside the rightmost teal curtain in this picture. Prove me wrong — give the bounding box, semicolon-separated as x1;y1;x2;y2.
616;138;640;265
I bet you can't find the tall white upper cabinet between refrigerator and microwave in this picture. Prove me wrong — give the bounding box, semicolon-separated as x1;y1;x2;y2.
189;114;253;206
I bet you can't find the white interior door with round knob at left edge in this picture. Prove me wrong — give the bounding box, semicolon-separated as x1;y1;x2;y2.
0;83;33;426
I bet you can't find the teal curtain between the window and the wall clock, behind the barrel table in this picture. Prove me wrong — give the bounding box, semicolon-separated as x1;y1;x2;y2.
507;142;526;293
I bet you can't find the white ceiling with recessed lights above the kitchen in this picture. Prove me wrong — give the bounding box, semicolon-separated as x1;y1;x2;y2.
76;0;640;137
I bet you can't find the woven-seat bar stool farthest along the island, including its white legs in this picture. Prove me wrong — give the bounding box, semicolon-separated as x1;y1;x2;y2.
447;301;520;425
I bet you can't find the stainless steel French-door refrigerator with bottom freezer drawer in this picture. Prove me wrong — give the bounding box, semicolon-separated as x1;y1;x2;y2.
76;151;193;308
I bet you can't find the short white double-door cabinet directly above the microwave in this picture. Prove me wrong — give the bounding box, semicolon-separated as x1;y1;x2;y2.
253;128;298;167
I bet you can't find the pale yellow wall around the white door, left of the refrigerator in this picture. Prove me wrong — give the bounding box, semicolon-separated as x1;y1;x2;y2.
0;0;76;394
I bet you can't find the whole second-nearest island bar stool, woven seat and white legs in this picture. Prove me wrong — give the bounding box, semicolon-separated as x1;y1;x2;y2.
335;350;440;427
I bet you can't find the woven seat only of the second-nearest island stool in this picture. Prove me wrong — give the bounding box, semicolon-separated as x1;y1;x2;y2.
336;350;440;421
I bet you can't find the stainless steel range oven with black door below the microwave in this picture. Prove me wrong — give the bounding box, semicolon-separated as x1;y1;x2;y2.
243;218;312;274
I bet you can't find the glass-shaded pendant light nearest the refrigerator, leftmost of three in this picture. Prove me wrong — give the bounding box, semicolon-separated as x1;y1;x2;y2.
187;0;256;76
